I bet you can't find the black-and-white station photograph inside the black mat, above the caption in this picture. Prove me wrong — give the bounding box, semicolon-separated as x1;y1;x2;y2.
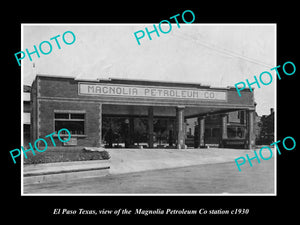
20;23;276;196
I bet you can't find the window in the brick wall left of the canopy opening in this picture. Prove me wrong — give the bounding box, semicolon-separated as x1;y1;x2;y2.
54;112;85;135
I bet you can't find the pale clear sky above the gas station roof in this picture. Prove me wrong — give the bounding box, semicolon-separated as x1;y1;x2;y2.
21;22;277;115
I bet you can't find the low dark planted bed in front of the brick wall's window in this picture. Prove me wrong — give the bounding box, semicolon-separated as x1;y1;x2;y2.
24;147;110;164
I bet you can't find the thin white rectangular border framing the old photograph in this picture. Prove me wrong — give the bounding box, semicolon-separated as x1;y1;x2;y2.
21;23;277;196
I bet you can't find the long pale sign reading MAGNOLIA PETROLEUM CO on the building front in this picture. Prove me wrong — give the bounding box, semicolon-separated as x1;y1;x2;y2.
78;83;227;101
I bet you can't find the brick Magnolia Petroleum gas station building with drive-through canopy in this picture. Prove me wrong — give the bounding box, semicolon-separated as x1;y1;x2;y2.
31;75;255;149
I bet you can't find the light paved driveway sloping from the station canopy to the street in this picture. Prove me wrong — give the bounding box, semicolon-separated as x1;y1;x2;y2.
107;148;270;174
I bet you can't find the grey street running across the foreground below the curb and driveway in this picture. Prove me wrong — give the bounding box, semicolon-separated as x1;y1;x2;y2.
24;159;275;195
